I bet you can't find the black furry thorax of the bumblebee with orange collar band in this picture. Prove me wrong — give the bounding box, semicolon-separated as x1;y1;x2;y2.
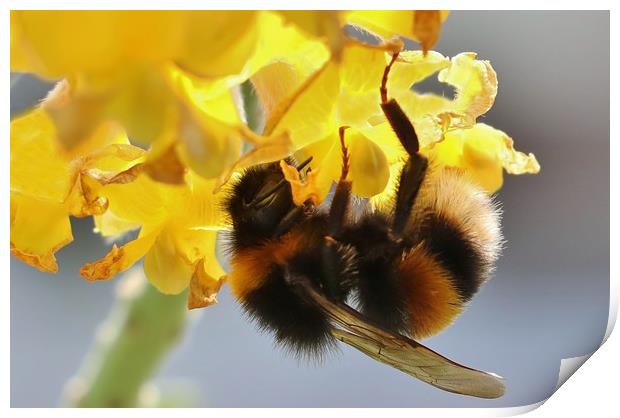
229;213;357;358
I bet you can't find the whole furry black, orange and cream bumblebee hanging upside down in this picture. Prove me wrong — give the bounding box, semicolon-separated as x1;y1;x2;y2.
225;49;503;397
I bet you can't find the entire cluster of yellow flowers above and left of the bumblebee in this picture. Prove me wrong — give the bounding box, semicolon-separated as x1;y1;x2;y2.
11;11;539;308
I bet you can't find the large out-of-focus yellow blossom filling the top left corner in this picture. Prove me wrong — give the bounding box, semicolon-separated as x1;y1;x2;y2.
11;11;329;183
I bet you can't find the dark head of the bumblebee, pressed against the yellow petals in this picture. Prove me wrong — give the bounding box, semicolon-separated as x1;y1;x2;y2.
226;157;312;246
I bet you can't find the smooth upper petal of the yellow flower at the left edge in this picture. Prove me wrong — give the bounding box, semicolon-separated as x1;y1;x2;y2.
11;109;74;202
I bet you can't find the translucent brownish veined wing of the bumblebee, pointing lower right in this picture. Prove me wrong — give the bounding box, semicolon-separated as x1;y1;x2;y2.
306;286;505;399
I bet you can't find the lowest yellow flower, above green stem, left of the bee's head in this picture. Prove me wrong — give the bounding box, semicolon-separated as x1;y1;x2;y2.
81;171;225;303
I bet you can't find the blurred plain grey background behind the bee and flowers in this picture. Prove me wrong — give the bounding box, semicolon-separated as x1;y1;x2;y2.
11;11;610;407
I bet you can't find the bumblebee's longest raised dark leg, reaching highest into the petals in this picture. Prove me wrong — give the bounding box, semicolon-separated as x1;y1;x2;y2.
379;53;428;234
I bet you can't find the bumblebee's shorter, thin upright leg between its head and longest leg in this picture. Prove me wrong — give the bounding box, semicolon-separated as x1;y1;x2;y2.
327;126;351;237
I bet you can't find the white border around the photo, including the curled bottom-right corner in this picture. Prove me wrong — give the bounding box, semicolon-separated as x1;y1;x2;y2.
0;0;620;418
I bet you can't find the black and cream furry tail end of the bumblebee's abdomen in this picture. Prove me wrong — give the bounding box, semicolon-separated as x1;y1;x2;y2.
406;164;503;301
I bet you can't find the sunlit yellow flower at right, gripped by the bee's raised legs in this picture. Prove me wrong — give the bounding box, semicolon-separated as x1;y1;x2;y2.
252;36;538;199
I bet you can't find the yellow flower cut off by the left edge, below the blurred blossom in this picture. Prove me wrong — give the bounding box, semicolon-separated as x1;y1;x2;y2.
11;108;144;272
